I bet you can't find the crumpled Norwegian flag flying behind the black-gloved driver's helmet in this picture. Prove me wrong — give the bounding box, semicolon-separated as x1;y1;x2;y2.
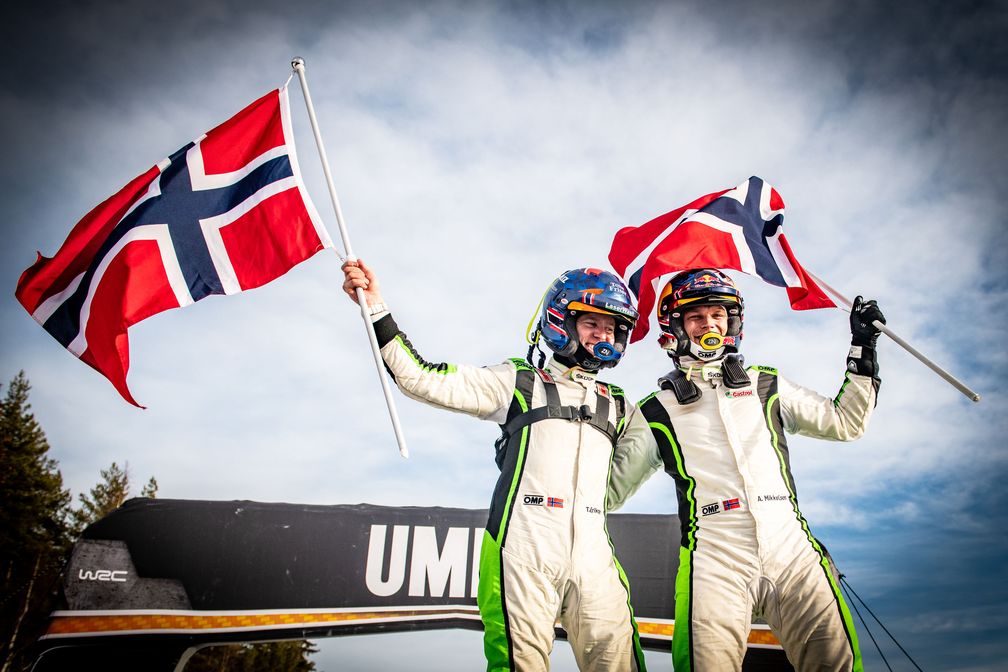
609;176;836;343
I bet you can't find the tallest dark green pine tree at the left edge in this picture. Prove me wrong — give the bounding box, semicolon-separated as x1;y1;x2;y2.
0;371;71;672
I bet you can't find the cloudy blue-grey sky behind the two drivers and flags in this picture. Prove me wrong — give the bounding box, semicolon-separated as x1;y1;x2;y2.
0;1;1008;671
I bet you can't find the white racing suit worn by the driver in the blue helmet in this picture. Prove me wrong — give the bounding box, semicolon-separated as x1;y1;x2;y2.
374;313;644;672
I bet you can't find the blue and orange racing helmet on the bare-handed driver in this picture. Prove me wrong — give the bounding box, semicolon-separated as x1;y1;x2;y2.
538;268;637;371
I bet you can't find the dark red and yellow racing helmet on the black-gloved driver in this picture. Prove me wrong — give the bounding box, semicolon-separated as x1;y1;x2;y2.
657;268;745;362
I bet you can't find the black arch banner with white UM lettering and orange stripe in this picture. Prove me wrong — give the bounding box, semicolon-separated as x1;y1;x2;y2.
35;499;787;672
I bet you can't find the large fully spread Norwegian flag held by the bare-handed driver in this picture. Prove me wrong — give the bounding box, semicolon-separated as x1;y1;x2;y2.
15;87;333;406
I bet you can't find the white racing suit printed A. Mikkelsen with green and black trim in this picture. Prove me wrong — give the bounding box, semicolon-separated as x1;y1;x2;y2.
609;363;878;672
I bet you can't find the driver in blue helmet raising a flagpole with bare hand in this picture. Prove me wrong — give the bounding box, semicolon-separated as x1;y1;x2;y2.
343;260;644;672
